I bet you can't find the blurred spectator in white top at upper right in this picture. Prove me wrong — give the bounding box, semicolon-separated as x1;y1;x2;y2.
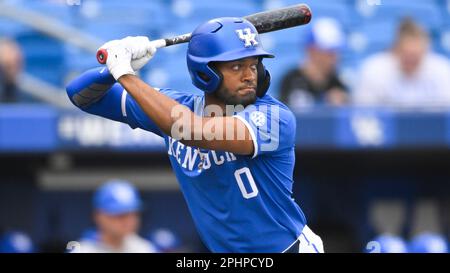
353;19;450;107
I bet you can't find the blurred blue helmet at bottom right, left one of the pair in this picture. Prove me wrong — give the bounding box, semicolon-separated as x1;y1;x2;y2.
365;234;408;253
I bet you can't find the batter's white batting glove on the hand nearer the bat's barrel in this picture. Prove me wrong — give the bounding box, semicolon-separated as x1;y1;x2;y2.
121;36;156;72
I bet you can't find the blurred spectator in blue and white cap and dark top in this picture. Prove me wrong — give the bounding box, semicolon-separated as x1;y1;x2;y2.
280;18;348;111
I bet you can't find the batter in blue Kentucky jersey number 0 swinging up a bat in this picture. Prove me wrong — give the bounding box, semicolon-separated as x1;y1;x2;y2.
67;17;323;253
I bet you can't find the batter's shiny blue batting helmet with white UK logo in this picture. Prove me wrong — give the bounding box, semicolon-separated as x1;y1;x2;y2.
187;17;274;97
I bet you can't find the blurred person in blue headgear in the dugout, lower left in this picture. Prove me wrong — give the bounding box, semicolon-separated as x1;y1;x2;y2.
73;180;156;253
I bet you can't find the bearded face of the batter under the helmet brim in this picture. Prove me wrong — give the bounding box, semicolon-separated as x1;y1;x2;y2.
214;57;259;106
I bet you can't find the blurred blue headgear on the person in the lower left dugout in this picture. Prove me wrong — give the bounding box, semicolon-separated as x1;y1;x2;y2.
94;180;142;215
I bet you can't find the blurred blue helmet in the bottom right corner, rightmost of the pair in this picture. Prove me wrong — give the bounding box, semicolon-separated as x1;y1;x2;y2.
409;232;448;253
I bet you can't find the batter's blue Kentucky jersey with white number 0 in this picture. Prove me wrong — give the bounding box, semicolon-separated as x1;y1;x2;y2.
68;67;306;252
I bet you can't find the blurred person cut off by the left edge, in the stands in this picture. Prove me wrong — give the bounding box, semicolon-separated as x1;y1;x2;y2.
0;39;23;102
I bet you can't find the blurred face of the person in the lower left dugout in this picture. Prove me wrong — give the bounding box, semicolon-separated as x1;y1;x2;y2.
96;212;139;238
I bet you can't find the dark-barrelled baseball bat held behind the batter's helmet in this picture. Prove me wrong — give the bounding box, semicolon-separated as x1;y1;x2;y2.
97;4;312;64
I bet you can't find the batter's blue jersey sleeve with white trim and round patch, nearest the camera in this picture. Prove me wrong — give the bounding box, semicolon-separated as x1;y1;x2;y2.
234;100;296;158
